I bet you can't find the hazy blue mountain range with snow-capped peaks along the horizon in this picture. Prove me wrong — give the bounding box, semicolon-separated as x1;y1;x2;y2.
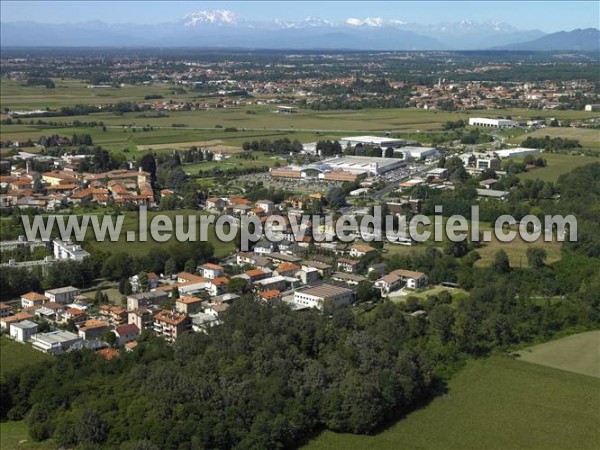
0;10;600;51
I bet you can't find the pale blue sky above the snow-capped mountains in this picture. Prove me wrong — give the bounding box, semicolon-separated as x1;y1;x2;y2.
0;0;600;33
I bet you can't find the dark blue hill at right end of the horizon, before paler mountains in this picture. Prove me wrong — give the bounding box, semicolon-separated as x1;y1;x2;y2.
495;28;600;52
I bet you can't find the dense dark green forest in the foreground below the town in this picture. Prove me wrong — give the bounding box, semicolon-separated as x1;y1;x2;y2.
0;163;600;449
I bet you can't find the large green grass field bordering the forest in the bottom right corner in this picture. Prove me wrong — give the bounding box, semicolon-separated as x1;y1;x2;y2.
304;357;600;450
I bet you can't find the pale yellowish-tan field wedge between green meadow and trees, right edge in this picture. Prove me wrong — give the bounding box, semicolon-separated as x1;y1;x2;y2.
519;330;600;378
